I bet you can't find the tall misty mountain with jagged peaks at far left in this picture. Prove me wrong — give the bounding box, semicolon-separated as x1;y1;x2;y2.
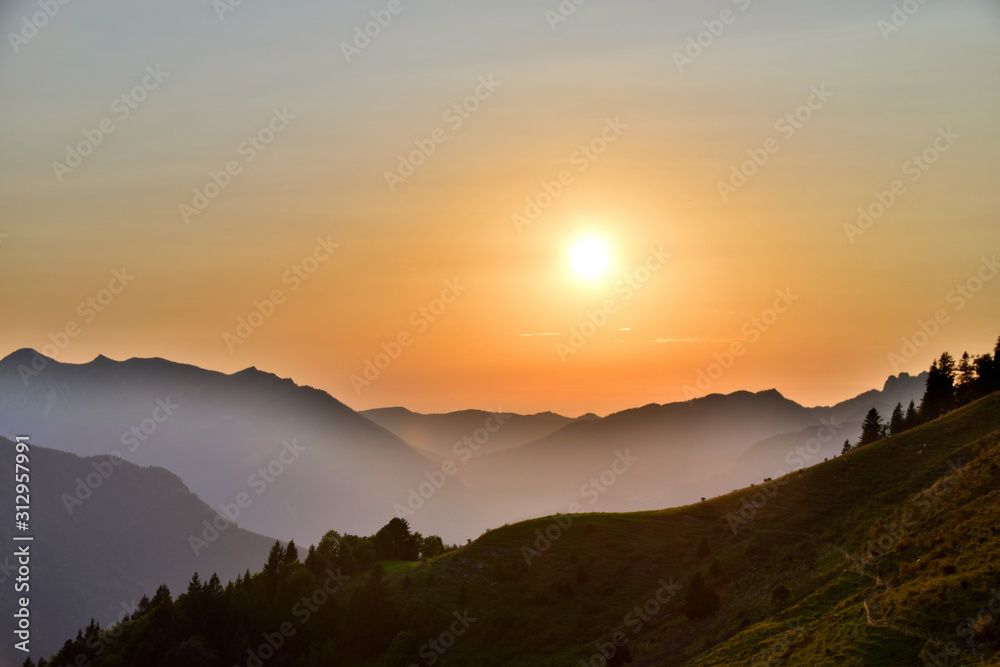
0;350;468;543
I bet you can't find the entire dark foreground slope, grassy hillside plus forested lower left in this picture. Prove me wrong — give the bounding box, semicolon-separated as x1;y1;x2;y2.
33;394;1000;667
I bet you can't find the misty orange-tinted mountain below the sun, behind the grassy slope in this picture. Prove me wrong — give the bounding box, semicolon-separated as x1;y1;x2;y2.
456;373;926;520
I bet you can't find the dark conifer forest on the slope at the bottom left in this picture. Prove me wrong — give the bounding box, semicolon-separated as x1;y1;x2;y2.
23;518;457;667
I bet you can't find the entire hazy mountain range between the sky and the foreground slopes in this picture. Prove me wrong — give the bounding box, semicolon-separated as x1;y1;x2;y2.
0;349;924;543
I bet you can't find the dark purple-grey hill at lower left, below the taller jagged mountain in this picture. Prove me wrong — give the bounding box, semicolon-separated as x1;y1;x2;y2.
0;438;274;665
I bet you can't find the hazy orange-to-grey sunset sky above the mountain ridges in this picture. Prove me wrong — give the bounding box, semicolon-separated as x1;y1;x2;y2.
0;0;1000;415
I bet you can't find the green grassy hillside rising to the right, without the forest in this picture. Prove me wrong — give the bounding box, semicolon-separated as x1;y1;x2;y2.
372;394;1000;665
